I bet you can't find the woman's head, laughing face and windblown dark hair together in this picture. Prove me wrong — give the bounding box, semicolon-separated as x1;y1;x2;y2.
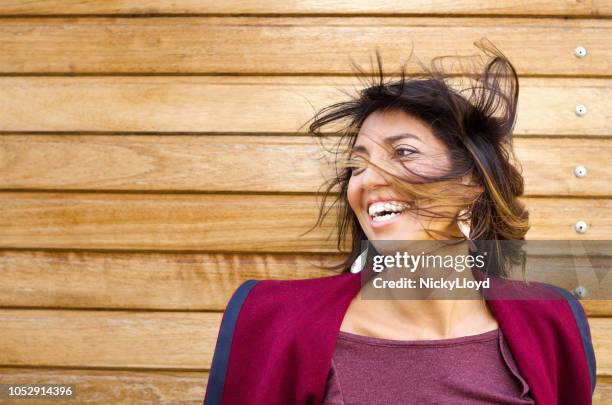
309;39;529;273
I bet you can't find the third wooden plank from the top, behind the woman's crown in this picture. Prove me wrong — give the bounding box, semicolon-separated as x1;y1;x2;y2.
0;75;612;136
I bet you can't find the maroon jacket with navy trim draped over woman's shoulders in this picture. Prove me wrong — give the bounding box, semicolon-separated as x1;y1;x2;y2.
204;268;595;405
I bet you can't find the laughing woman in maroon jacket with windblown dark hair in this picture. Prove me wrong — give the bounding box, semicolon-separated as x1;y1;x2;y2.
204;43;595;405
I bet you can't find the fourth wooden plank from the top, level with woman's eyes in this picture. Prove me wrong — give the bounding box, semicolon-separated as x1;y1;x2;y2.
0;134;612;196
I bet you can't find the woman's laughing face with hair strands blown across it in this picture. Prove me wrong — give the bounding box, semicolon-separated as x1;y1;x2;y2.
347;111;458;240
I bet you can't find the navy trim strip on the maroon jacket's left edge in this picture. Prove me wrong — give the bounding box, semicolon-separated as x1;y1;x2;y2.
204;280;259;405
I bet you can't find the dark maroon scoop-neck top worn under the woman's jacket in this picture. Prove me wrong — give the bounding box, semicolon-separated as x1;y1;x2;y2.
323;329;534;405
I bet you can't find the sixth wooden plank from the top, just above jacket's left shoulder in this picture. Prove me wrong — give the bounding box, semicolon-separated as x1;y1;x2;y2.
0;251;612;316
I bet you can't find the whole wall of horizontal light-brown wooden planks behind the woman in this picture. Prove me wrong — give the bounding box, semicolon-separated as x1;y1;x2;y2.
0;0;612;404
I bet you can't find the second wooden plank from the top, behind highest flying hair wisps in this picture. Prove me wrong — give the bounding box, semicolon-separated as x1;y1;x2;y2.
0;17;612;76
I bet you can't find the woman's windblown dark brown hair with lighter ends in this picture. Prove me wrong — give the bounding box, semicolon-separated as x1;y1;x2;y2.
307;39;529;274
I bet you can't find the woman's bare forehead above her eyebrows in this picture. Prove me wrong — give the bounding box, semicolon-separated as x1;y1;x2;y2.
355;110;442;147
